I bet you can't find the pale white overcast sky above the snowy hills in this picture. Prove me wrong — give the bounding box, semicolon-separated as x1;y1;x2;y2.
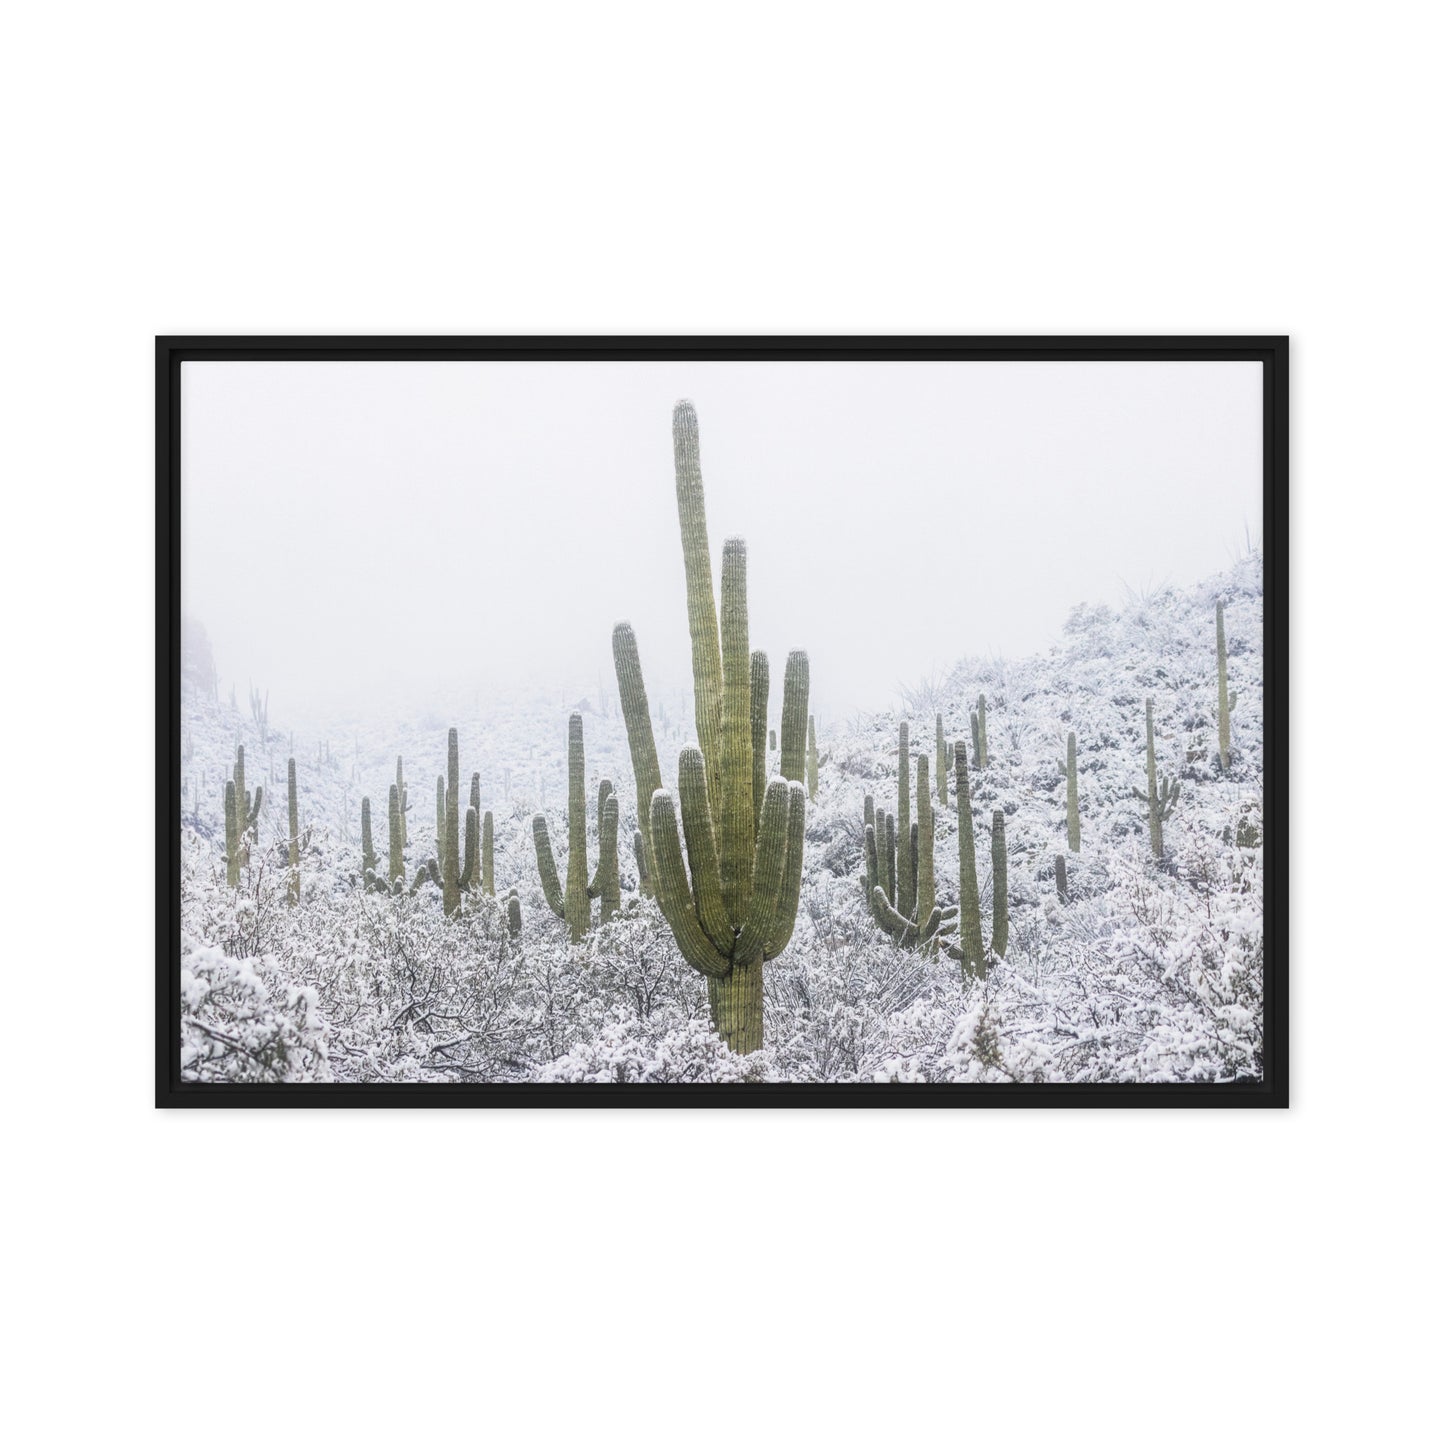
182;361;1261;720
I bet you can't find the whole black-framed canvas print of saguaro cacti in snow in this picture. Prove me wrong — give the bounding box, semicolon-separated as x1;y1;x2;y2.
156;337;1289;1107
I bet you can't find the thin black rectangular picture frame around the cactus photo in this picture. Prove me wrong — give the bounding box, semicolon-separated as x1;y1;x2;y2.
156;337;1289;1108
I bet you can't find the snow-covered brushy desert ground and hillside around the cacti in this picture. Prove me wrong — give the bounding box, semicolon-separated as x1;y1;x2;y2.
181;556;1263;1082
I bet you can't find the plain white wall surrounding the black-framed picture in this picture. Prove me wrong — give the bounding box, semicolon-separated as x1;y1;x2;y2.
8;0;1441;1442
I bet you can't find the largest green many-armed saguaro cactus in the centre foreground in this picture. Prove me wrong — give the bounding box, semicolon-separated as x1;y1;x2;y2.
613;402;808;1053
